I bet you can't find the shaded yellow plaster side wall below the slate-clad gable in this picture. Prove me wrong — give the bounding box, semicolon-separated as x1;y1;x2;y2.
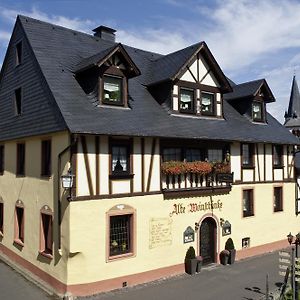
0;132;69;282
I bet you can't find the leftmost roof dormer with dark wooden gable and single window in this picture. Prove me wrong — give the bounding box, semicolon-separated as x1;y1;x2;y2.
75;44;140;107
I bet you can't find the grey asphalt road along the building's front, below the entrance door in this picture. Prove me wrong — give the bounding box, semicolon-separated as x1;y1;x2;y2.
82;252;283;300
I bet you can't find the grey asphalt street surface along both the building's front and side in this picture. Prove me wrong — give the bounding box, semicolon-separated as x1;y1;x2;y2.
0;252;283;300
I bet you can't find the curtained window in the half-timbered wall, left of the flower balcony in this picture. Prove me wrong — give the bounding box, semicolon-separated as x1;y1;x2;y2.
111;141;131;176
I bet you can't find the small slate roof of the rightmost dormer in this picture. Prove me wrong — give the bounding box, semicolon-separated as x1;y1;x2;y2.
224;79;274;101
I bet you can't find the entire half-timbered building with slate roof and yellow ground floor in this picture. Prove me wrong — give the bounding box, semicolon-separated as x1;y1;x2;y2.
0;16;299;295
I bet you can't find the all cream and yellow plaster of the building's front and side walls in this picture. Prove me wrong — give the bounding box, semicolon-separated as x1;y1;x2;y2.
0;132;299;296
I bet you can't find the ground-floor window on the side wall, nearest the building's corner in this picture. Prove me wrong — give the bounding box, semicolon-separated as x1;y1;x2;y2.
40;212;53;255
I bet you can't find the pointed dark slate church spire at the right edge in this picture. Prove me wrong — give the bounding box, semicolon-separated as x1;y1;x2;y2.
284;76;300;128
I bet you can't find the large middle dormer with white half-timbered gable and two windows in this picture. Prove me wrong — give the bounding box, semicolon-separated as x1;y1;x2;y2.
148;42;232;118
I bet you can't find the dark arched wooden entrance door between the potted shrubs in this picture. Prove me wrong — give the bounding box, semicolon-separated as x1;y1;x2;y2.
199;217;217;264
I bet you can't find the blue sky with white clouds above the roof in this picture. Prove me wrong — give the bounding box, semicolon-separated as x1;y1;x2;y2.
0;0;300;122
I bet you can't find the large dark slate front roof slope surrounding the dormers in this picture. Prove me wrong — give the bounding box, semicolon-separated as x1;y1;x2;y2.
1;16;298;144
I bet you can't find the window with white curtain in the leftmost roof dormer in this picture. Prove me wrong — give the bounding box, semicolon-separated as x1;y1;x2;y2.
102;75;124;105
